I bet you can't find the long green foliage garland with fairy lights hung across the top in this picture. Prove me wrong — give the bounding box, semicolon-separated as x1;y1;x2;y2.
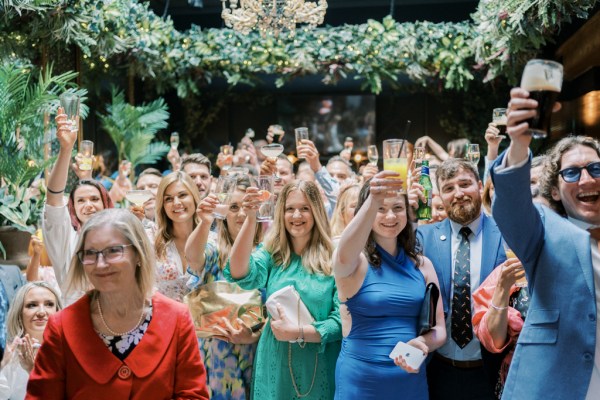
0;0;598;97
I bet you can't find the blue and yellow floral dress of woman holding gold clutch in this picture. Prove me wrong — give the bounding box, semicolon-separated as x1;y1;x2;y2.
188;242;256;400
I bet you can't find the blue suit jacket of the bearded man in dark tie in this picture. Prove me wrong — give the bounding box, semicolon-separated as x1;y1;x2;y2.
417;214;506;318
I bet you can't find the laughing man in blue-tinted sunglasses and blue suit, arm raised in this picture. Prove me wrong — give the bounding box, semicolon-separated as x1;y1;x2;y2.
491;88;600;400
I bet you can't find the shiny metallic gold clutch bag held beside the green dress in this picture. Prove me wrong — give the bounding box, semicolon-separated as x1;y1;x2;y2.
183;281;264;338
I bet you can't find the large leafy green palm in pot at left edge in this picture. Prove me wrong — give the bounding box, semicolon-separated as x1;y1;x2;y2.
0;60;86;266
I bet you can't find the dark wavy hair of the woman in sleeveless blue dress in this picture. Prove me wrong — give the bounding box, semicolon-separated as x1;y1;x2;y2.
354;179;422;268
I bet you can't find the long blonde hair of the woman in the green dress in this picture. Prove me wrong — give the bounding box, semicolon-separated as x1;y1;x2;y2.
264;181;333;275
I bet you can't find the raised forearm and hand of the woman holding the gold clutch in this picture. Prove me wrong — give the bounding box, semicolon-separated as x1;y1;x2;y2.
185;194;219;274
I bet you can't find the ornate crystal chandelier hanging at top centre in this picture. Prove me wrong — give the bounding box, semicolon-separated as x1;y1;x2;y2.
221;0;327;37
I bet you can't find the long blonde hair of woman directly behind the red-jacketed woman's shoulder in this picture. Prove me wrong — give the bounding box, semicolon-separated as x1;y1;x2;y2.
154;171;200;260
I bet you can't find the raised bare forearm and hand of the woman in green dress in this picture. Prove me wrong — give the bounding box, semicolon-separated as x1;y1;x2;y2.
229;187;260;279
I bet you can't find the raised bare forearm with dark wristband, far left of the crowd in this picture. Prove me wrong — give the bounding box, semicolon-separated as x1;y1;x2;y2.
46;107;77;207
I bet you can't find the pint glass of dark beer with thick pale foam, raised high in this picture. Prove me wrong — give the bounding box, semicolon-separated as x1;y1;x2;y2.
521;60;563;139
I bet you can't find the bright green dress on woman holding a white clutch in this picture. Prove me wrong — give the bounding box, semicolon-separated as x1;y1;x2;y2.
224;248;342;400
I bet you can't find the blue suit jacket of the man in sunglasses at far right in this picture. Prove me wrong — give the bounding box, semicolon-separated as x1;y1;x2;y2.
491;155;600;400
